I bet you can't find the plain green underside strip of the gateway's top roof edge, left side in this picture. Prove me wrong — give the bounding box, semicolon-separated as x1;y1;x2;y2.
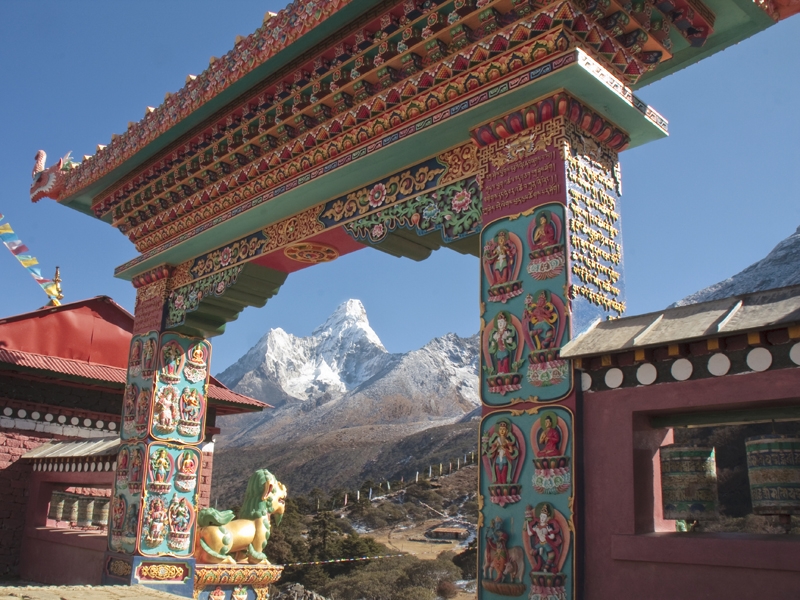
60;0;383;216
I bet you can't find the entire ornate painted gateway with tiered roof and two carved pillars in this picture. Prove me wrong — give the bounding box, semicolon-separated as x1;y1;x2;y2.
31;0;797;600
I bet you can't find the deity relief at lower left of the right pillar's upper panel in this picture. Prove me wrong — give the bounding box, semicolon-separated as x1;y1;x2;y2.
482;310;525;395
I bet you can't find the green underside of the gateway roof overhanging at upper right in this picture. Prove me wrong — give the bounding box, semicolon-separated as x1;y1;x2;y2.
631;0;775;90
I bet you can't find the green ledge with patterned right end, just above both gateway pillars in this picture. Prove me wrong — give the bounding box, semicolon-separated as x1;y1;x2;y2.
115;50;668;280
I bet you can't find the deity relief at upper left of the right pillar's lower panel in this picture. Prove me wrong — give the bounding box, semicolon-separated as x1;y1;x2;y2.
481;418;525;507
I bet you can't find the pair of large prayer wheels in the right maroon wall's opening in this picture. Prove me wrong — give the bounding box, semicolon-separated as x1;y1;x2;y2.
661;434;800;521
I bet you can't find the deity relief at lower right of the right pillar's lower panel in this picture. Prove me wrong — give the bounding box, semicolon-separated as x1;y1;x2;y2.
522;502;571;600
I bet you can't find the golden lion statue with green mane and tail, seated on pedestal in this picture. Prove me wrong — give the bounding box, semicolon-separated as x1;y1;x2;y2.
194;469;286;565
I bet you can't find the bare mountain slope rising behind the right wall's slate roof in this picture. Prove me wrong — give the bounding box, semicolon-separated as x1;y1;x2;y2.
672;227;800;306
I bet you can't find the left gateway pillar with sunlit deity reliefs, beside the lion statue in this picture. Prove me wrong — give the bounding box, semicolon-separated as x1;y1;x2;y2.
103;267;211;596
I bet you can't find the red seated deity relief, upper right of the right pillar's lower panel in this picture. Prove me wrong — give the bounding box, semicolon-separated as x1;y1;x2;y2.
531;410;572;494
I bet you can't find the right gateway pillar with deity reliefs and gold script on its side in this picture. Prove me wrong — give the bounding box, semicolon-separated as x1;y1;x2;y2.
471;92;644;600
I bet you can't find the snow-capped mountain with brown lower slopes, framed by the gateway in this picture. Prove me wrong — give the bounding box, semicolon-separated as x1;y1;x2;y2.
214;300;480;495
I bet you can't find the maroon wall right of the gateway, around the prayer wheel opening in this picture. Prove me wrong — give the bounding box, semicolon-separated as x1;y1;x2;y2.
583;369;800;600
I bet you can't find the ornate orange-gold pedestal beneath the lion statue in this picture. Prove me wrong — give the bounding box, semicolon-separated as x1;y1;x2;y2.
194;564;283;600
